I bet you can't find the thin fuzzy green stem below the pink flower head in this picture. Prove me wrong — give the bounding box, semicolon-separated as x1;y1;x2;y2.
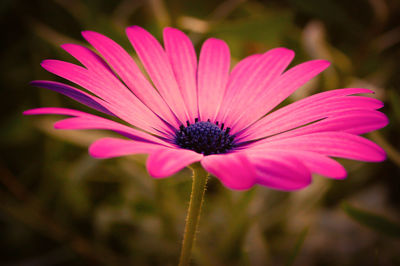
179;163;208;266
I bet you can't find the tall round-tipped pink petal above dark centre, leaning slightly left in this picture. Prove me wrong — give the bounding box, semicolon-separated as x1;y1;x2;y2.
164;28;199;123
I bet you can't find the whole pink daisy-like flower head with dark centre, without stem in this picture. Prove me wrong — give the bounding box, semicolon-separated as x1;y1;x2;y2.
25;26;388;190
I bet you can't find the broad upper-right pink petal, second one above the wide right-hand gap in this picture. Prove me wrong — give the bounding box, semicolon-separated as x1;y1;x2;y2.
221;48;294;125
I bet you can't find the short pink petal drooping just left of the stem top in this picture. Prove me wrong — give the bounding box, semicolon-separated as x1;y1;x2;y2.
146;148;204;178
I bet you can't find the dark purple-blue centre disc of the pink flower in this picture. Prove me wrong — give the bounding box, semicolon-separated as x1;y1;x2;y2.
175;118;235;155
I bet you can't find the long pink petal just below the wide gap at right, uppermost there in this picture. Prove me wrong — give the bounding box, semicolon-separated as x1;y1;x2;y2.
238;89;383;140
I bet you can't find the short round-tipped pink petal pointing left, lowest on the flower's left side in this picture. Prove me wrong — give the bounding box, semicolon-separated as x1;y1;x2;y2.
89;138;162;159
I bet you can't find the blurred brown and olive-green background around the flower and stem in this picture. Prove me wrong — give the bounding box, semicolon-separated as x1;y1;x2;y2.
0;0;400;266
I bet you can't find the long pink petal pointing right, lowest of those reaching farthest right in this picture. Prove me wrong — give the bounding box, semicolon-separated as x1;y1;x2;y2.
252;132;386;162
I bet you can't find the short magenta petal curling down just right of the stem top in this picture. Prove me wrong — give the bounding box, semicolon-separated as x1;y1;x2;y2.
201;152;256;190
